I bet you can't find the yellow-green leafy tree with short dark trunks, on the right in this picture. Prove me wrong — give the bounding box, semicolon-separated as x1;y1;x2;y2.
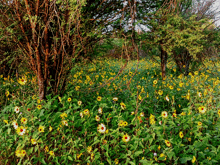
140;0;219;78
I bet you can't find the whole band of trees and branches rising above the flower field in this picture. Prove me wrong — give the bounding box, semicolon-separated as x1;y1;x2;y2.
0;0;219;99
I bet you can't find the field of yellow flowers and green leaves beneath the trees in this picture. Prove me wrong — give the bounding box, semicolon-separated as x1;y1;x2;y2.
0;60;220;165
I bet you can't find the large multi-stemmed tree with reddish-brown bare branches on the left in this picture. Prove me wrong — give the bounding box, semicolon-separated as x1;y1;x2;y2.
0;0;99;100
